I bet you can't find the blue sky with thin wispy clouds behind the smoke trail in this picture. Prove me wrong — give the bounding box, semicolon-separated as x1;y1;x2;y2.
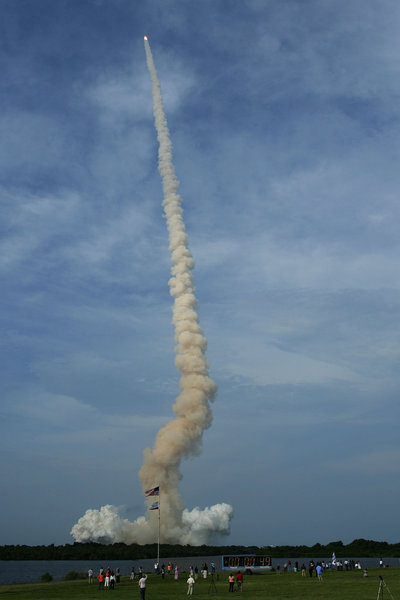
0;0;400;545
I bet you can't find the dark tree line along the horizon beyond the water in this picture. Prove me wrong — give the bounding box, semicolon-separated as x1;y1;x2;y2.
0;539;400;560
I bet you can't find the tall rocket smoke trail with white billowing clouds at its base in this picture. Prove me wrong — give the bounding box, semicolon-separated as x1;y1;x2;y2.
71;38;233;544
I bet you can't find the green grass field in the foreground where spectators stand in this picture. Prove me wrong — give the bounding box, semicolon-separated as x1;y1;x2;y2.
0;567;400;600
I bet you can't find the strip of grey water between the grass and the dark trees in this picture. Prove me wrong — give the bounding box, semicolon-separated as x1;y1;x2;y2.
0;556;400;584
